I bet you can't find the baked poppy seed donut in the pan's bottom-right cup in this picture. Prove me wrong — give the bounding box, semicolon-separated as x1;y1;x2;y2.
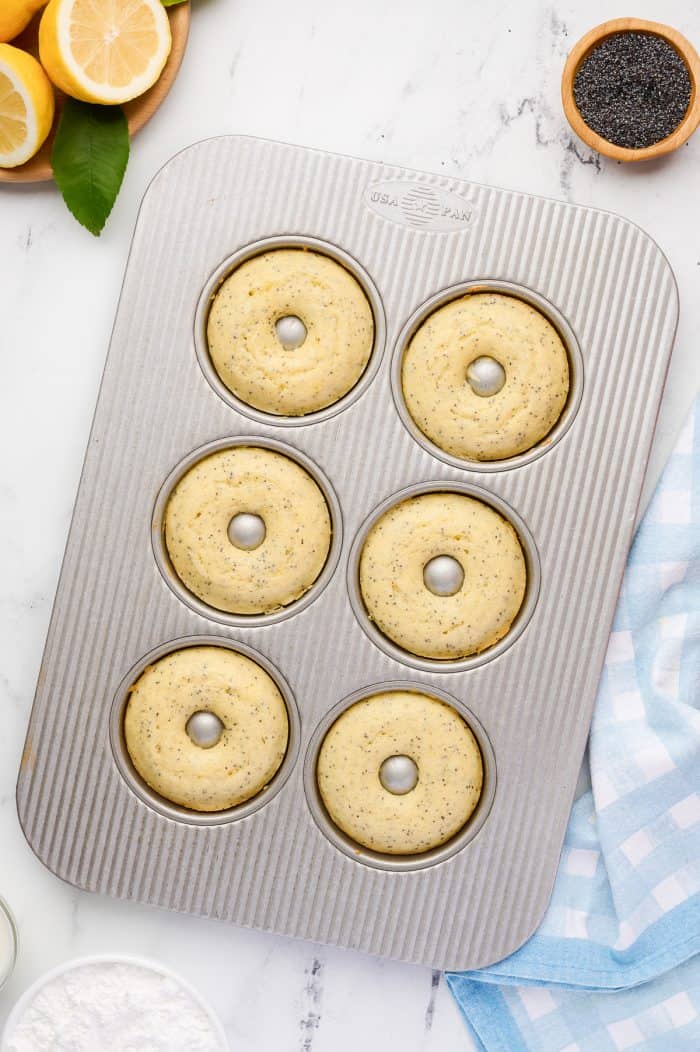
316;690;483;854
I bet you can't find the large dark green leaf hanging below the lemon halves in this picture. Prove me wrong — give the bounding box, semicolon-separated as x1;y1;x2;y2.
52;99;129;237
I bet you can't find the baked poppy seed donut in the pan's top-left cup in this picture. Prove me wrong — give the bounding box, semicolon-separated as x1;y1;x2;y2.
206;248;375;417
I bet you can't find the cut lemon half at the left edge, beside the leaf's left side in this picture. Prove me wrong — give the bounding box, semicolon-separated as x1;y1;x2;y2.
0;44;54;168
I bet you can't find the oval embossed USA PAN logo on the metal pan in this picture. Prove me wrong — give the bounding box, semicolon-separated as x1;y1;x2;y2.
364;180;475;230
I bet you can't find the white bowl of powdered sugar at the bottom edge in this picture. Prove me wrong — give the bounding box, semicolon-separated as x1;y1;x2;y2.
0;956;229;1052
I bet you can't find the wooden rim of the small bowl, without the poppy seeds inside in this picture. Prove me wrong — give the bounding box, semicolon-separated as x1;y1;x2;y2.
561;18;700;161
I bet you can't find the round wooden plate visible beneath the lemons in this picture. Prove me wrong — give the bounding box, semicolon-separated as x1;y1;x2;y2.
0;3;189;183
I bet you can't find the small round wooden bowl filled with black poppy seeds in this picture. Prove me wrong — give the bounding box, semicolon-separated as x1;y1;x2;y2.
561;18;700;161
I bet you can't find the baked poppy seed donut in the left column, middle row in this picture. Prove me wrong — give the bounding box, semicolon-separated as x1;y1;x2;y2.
164;446;332;614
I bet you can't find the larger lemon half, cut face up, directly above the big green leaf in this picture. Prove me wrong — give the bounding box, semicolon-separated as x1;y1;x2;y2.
39;0;173;105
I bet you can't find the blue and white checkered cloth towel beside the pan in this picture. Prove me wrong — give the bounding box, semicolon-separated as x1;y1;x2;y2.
447;402;700;1052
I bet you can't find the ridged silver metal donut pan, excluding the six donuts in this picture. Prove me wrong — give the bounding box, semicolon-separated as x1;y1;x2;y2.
17;137;678;969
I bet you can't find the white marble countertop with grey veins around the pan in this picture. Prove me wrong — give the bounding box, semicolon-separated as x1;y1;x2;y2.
0;0;700;1052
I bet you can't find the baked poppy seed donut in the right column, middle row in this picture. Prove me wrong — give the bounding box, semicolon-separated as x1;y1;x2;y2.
360;492;526;660
